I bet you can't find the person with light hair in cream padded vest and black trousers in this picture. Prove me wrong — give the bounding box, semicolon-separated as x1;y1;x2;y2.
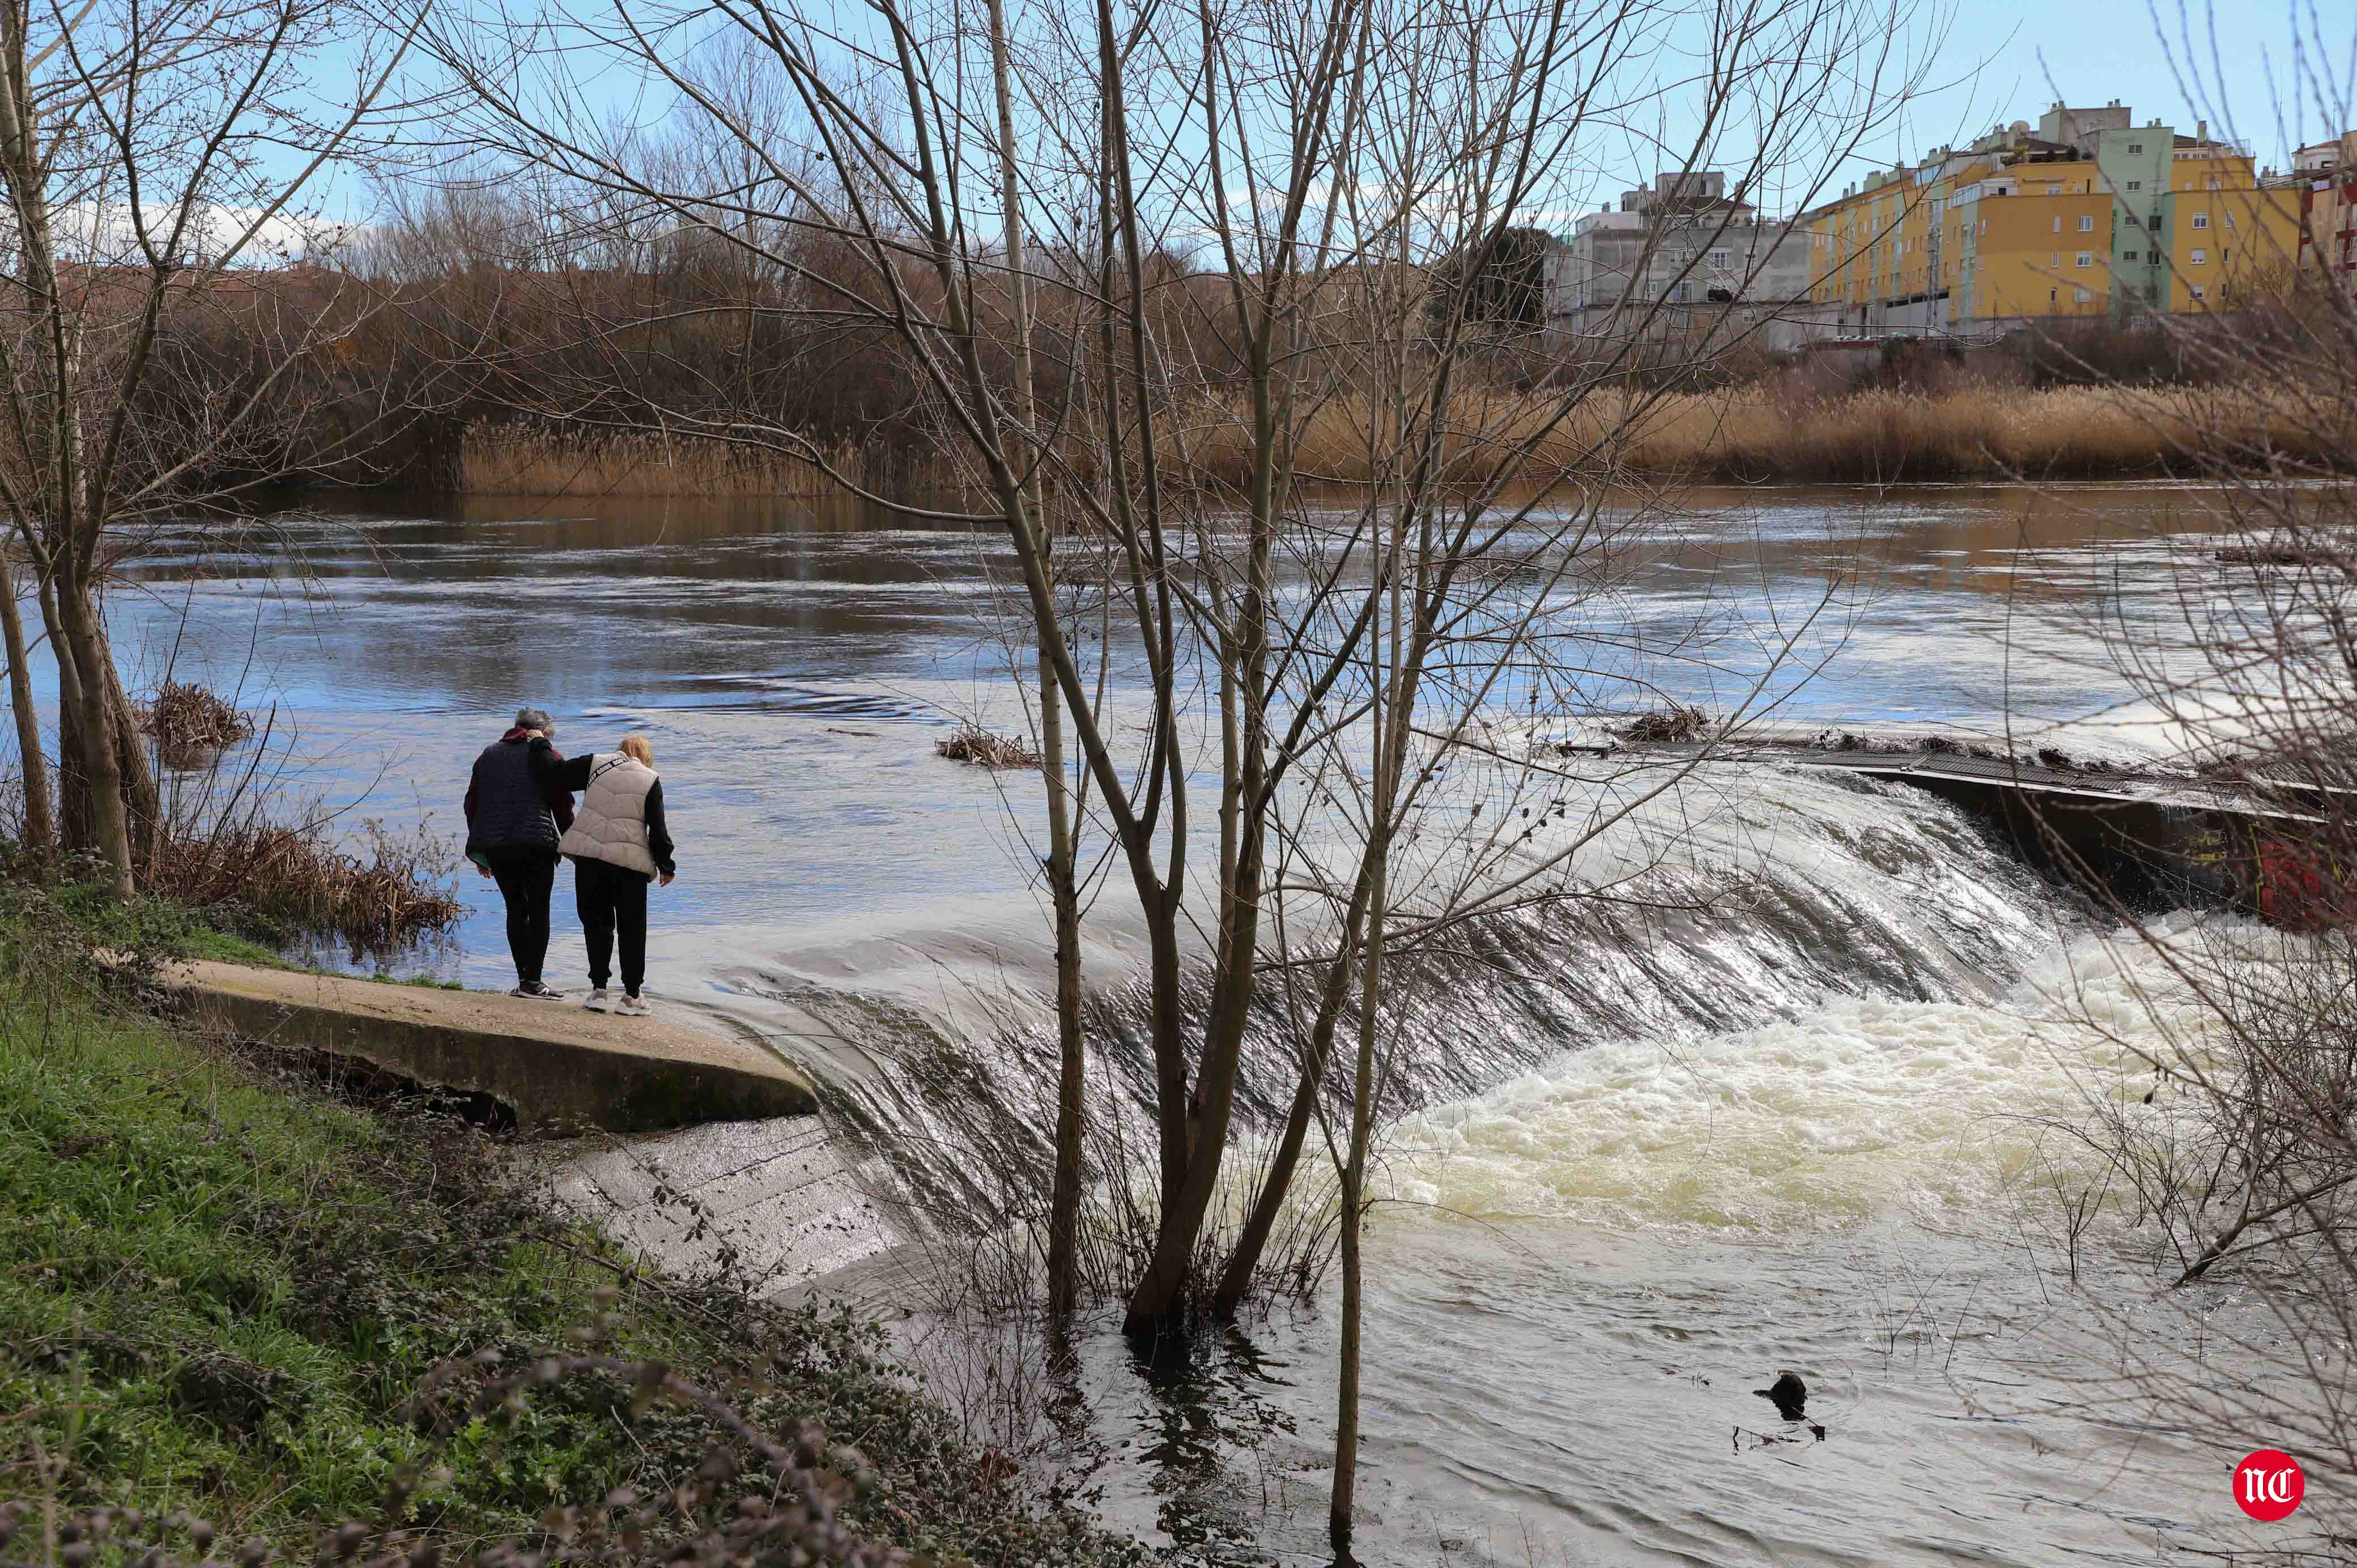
556;736;679;1014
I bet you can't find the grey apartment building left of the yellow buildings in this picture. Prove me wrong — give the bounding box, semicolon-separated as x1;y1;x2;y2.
1546;170;1808;349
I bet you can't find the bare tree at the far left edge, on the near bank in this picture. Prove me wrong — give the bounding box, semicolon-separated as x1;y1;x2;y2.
0;0;417;896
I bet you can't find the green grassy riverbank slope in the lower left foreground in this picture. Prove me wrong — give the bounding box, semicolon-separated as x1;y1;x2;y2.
0;882;1134;1563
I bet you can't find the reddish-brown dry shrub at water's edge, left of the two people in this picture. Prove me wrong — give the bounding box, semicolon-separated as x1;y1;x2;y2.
146;816;465;957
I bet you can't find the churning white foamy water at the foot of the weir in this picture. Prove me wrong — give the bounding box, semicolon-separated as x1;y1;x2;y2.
1386;919;2246;1231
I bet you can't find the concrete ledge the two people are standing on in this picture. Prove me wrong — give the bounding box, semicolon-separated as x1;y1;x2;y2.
167;962;818;1132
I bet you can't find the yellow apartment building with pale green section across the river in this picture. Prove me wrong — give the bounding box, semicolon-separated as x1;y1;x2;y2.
1798;99;2298;337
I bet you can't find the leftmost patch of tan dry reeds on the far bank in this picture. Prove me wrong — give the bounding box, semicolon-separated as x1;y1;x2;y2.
460;424;860;497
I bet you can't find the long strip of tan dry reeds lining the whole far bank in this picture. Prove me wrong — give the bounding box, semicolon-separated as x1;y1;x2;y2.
445;382;2352;497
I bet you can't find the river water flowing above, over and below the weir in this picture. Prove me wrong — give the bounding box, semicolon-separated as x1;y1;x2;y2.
113;485;2309;1563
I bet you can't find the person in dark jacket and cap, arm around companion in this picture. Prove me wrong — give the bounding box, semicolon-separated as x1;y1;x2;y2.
467;708;573;1002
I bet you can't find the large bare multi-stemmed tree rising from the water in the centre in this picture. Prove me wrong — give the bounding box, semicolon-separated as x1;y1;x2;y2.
439;0;1912;1367
